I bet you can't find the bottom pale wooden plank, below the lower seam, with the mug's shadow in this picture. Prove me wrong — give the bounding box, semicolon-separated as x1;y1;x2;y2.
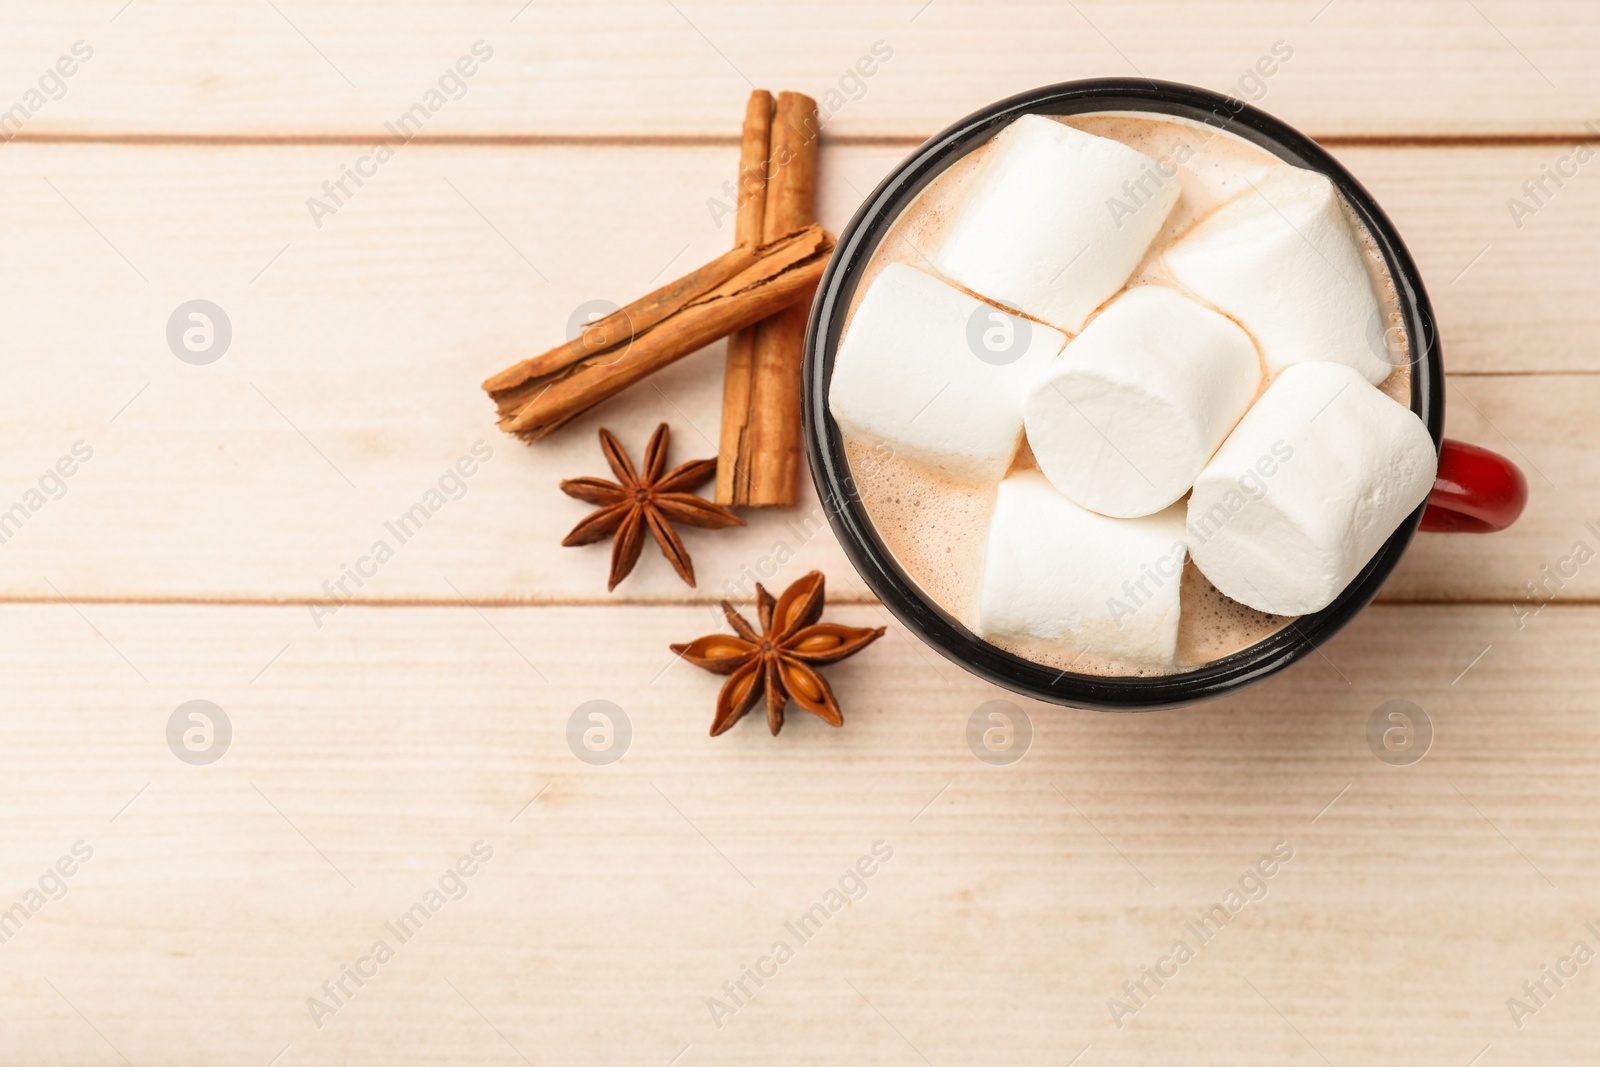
0;605;1600;1067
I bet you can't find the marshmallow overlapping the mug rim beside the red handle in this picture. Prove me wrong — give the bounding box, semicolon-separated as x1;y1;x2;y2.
1189;363;1438;614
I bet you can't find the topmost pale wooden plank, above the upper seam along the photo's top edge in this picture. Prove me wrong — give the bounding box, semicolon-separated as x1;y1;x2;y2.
9;0;1600;139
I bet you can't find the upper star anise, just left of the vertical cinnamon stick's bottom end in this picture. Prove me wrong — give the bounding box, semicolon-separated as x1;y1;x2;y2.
562;422;744;592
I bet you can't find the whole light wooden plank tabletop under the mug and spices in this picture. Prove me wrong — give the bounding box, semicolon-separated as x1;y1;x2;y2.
0;0;1600;1067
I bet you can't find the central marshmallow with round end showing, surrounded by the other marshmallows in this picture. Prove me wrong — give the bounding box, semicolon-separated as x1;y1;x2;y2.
1022;286;1261;518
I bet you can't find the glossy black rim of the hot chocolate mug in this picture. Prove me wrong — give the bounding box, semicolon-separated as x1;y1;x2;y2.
802;78;1445;712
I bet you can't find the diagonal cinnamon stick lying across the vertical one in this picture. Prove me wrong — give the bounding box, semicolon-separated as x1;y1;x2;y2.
483;226;834;442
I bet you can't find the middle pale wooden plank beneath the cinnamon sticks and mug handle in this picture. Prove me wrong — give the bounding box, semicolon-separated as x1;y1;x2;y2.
0;146;1600;603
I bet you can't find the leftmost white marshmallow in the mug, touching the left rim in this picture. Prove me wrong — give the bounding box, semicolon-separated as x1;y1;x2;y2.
827;262;1067;482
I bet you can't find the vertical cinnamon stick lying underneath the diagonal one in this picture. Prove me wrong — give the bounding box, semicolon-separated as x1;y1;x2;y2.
717;90;818;507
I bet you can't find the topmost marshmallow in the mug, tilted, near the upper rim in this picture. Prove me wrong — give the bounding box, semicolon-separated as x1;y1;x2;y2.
933;115;1181;333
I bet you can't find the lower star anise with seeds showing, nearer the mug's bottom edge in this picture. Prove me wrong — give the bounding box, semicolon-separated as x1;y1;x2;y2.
672;571;885;737
